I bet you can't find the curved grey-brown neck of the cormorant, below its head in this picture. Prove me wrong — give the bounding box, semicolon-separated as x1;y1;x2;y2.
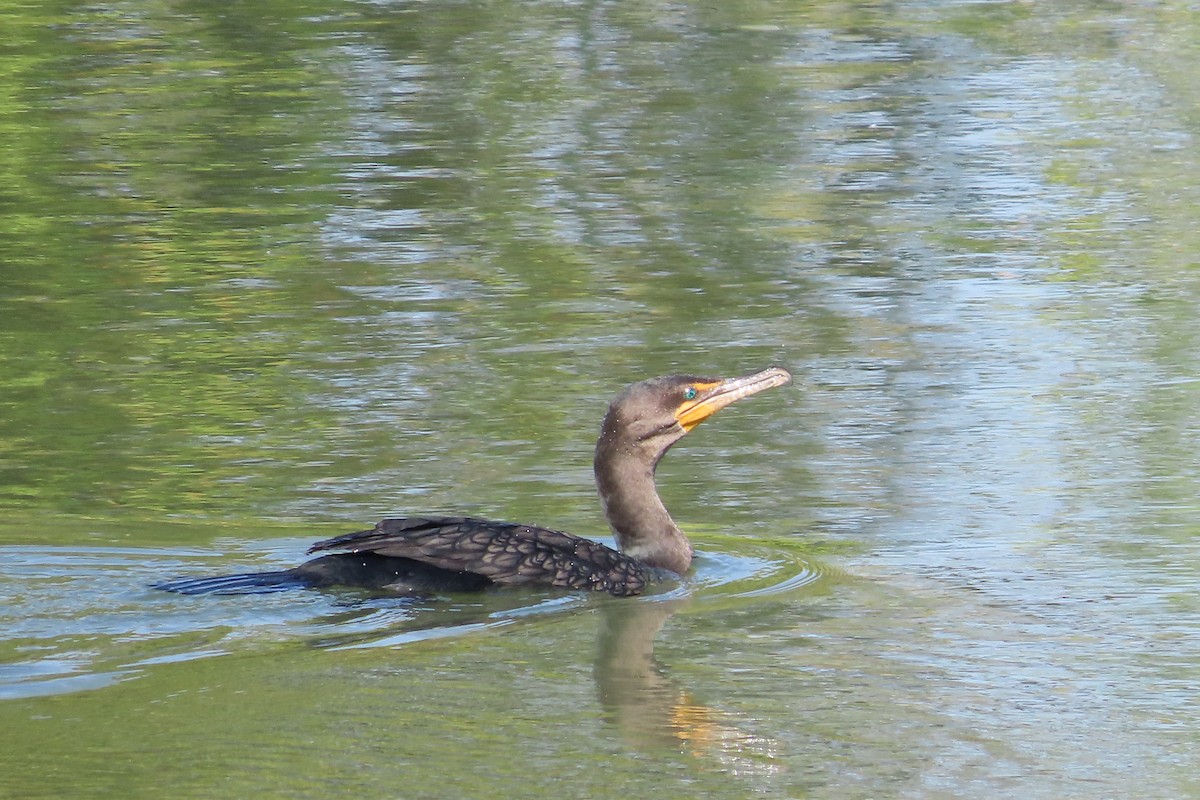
595;435;692;575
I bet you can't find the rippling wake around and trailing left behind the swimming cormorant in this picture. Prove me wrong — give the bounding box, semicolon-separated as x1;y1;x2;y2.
0;540;828;698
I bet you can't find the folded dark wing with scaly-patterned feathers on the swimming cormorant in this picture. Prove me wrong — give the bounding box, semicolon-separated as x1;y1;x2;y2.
308;517;649;595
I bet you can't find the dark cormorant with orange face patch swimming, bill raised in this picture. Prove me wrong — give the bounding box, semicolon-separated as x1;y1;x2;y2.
156;367;792;596
